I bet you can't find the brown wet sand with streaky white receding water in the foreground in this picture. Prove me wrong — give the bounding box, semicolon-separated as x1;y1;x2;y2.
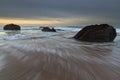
0;39;120;80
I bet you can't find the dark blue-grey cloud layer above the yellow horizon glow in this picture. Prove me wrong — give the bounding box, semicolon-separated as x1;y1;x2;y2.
0;0;120;22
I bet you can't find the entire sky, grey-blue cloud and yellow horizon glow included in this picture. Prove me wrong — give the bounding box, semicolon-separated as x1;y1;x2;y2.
0;0;120;25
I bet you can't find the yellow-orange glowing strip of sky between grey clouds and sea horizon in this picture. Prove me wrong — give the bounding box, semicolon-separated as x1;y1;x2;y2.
0;17;119;26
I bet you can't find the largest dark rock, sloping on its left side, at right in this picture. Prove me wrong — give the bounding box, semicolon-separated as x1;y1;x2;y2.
74;24;117;42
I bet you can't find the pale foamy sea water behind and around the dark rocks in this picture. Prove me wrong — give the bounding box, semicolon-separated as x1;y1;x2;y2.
0;26;120;47
